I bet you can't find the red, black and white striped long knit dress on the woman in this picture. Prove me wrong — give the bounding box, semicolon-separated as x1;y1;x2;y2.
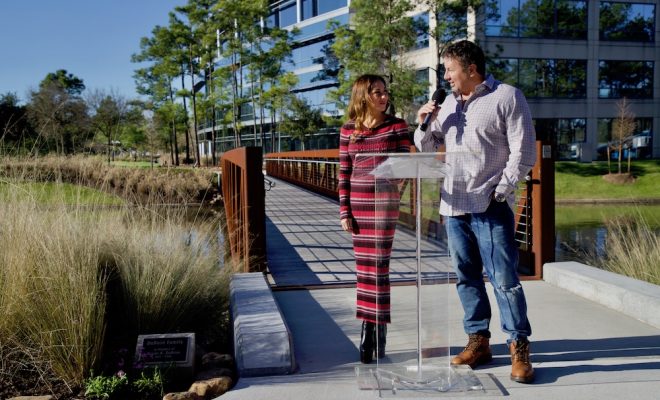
338;117;410;324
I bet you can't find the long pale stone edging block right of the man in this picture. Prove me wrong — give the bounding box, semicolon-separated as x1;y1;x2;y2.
543;261;660;328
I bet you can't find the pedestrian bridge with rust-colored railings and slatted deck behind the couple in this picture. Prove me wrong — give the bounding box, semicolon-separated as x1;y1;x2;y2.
222;141;554;287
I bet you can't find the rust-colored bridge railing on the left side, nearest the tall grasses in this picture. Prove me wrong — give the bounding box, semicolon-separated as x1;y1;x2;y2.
220;147;266;272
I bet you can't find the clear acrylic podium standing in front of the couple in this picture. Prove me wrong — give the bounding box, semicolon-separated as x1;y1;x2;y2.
353;153;484;397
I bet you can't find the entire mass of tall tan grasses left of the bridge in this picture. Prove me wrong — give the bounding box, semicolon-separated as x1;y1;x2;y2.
0;169;229;390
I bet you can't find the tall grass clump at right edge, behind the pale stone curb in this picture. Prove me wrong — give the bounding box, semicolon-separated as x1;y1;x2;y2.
603;216;660;285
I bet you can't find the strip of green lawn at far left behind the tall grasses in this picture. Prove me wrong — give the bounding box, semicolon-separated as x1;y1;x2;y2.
0;181;124;205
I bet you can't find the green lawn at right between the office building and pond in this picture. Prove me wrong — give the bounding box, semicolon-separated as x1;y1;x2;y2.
555;160;660;200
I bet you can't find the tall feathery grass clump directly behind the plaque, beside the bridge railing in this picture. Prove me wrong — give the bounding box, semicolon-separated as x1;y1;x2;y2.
105;208;228;341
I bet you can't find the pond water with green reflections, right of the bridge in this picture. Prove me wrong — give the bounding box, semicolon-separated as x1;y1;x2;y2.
555;204;660;266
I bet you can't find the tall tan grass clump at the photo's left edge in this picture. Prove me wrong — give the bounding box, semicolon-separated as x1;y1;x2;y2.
0;184;106;382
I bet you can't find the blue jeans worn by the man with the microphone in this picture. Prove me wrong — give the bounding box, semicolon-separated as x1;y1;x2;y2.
446;201;532;341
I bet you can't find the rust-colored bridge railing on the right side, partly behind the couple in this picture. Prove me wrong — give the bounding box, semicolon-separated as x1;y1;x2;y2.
264;140;555;279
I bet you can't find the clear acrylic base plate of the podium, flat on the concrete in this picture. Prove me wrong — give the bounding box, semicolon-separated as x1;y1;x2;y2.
355;365;486;397
